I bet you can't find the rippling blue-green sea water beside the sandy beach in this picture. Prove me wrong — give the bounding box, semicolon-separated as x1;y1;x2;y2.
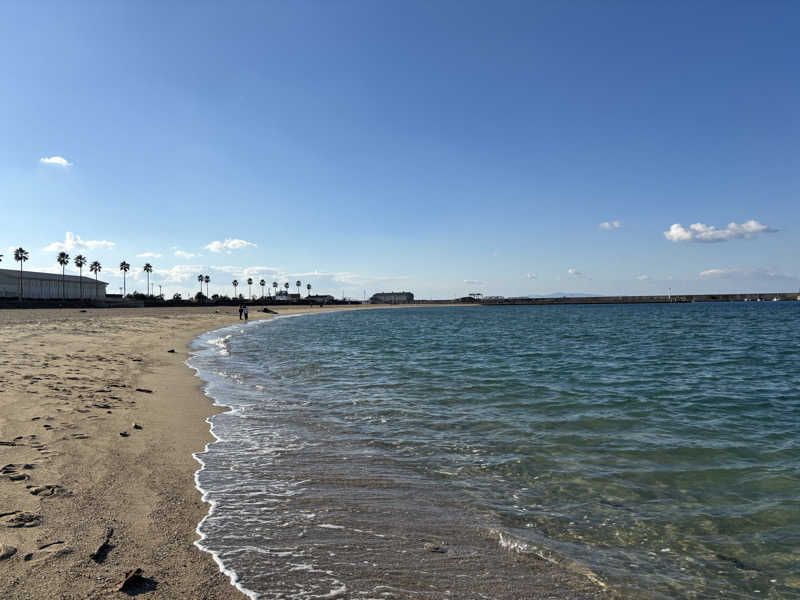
191;302;800;599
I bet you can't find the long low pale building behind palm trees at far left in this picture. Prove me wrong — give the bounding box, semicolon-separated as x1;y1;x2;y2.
0;269;108;300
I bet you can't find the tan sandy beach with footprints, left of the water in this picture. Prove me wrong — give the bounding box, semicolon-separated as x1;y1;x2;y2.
0;307;388;599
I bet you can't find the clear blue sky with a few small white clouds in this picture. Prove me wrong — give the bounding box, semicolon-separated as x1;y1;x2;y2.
0;1;800;298
